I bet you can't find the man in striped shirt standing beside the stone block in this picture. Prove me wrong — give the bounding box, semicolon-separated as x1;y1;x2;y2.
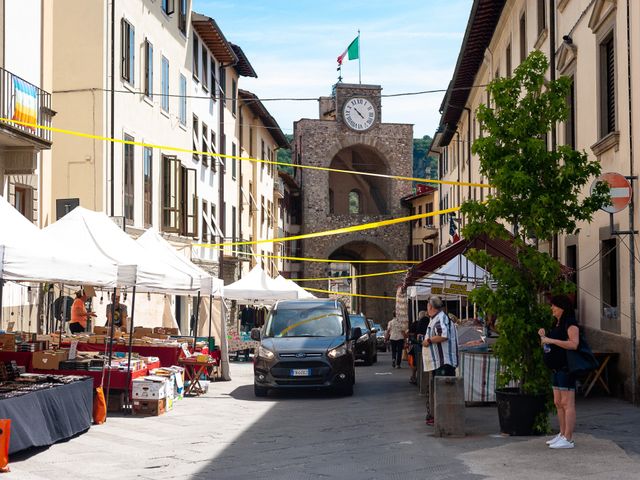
422;296;458;425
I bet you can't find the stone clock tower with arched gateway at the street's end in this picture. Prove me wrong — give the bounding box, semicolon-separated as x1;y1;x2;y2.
292;83;413;324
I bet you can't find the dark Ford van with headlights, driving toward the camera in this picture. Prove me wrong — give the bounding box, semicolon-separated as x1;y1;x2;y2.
251;299;362;397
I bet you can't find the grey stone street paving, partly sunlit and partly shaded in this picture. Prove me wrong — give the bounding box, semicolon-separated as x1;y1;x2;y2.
3;354;640;480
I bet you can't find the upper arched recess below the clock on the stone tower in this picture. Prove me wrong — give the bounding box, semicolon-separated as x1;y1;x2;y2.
327;144;391;215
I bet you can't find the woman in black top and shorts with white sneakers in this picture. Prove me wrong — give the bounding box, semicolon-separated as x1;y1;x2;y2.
538;295;580;448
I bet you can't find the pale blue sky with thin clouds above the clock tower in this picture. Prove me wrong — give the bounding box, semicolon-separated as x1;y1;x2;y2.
193;0;472;137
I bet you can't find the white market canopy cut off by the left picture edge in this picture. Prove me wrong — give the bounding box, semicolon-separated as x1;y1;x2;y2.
0;196;117;287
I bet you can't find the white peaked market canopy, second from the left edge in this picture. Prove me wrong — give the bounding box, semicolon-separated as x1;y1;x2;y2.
42;207;197;294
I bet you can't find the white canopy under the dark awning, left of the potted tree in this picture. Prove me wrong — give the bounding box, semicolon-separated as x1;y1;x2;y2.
407;254;492;300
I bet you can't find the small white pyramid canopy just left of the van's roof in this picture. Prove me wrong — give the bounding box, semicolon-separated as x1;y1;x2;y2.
223;265;298;303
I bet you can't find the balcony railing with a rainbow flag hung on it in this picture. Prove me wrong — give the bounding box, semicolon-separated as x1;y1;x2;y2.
0;68;53;144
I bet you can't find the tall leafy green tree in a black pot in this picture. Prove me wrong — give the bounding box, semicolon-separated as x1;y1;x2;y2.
461;51;609;435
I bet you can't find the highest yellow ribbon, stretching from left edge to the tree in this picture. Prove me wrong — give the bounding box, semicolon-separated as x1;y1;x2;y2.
0;117;491;188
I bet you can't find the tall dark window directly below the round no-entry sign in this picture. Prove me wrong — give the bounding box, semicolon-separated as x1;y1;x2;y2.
600;238;620;333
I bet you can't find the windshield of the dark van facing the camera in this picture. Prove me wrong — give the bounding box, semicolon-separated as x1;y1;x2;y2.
265;307;344;337
